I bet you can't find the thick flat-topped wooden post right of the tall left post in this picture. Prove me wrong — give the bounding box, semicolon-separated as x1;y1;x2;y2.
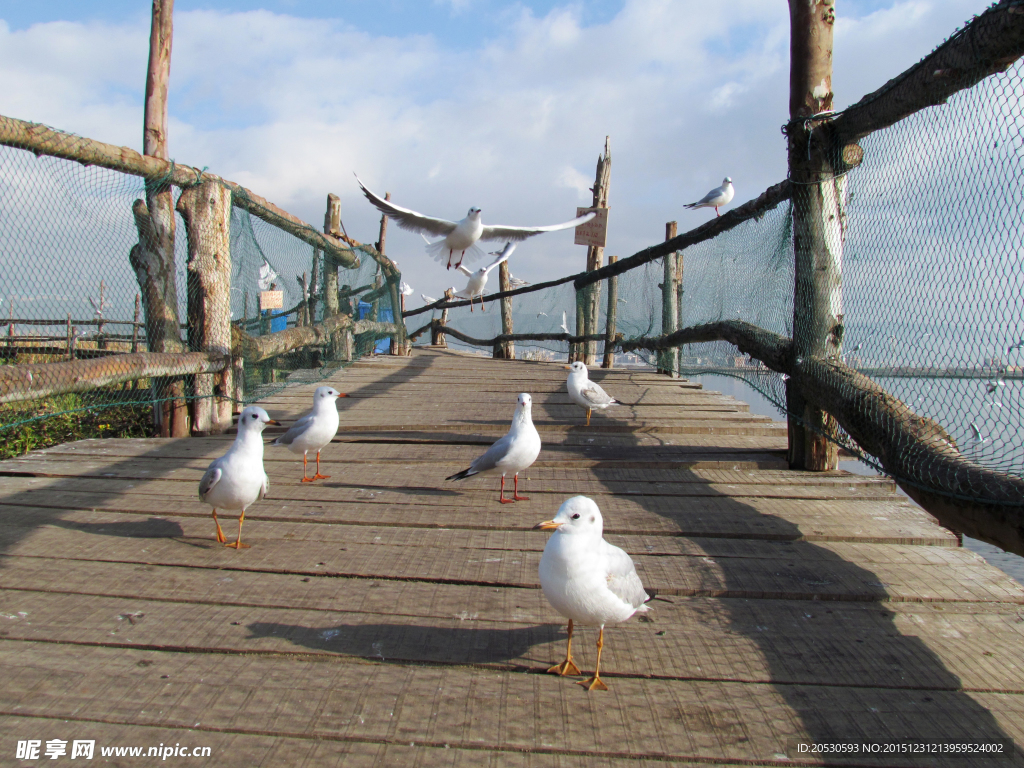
177;181;234;434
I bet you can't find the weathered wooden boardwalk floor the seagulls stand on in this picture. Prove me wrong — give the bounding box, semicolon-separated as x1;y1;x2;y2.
0;349;1024;768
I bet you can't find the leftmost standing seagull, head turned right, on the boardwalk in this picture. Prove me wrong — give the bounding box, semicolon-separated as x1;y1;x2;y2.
199;406;280;550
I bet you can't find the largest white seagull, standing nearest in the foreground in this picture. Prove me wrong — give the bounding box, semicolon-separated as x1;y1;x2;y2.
534;496;650;690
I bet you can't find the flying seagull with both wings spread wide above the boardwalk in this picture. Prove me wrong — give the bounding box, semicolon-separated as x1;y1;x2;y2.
355;176;597;269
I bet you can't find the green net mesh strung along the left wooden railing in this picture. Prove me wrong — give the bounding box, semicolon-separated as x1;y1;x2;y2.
0;126;398;455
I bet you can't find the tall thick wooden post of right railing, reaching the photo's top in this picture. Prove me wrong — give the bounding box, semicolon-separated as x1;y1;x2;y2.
786;0;846;471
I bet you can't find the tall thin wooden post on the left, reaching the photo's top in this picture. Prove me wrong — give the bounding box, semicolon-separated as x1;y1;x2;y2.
137;0;188;437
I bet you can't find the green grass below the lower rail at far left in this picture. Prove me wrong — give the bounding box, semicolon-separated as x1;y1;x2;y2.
0;389;154;459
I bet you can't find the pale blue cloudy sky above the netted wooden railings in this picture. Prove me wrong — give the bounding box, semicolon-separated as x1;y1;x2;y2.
0;0;988;306
